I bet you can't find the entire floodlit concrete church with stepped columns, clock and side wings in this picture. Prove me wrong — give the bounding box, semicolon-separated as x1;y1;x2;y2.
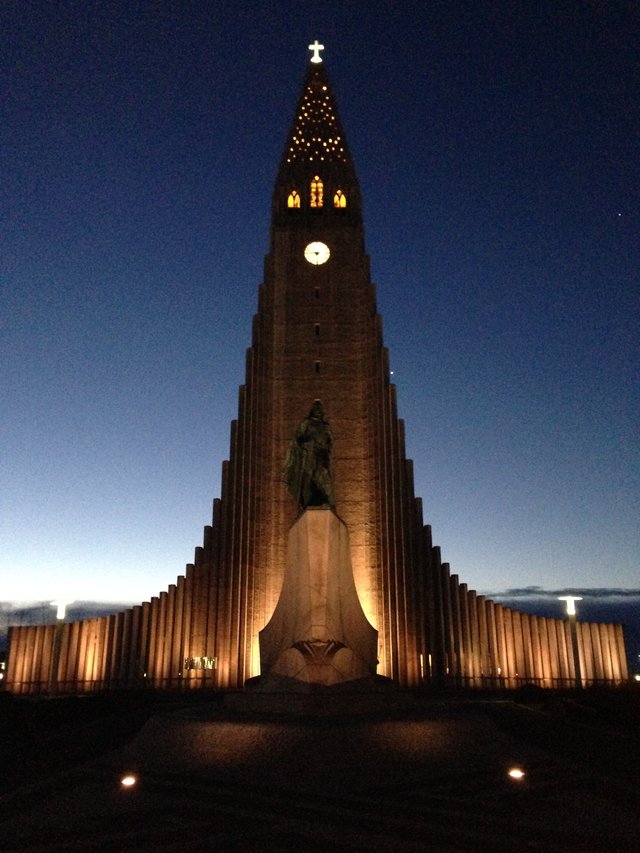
6;48;628;693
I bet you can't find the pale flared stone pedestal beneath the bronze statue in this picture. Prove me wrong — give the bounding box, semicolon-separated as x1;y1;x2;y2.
259;508;378;686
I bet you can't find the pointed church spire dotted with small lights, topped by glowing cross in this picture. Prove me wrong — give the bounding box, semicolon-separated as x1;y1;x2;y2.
273;47;360;224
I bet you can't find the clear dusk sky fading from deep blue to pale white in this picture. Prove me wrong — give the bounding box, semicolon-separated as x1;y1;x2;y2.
0;5;640;620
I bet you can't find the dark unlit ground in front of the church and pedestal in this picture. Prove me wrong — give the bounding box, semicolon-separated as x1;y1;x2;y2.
0;689;640;851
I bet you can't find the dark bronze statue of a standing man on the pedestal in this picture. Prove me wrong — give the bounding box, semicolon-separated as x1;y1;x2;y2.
284;400;335;509
